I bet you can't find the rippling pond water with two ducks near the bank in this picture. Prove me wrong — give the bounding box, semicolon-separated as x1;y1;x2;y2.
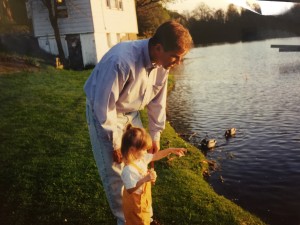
168;38;300;225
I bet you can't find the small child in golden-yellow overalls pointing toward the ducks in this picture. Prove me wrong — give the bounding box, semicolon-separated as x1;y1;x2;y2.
121;125;186;225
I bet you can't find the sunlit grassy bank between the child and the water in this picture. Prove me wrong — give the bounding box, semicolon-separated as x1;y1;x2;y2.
142;75;266;225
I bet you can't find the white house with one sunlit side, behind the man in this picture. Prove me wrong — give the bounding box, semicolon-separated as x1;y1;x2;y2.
27;0;138;67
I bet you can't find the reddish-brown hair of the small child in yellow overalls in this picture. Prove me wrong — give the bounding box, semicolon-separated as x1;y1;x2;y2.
121;124;152;163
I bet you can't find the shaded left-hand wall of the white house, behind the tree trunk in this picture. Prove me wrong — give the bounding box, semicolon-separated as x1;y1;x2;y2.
30;0;97;65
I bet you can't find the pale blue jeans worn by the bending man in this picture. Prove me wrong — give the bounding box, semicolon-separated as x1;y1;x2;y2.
86;100;143;225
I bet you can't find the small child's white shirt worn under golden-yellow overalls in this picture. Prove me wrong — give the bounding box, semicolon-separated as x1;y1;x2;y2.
121;153;153;194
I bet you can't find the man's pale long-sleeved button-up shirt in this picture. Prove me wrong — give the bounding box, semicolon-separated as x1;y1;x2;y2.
84;39;169;149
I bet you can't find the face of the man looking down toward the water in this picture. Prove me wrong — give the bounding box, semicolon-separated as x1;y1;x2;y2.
157;46;187;70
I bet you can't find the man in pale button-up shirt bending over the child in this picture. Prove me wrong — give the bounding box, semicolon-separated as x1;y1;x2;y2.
84;21;192;225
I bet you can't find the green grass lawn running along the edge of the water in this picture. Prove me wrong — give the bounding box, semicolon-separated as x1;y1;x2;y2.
0;64;264;225
